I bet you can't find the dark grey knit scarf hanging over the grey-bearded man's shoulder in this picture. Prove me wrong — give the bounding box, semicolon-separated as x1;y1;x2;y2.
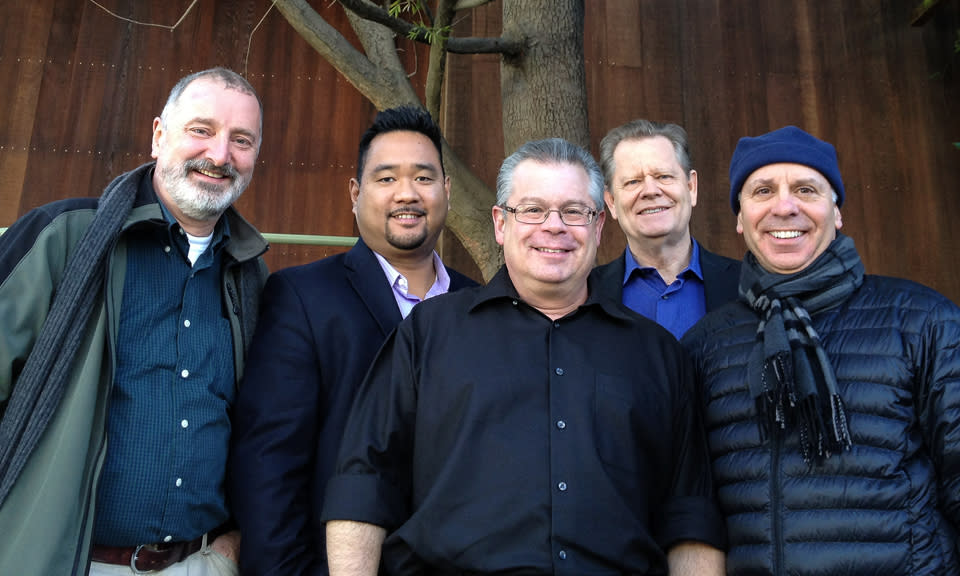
0;163;153;506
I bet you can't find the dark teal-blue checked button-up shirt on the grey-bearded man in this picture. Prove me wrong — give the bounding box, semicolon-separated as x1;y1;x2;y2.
94;197;236;546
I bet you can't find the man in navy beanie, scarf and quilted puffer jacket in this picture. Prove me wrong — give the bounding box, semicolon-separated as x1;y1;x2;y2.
683;126;960;576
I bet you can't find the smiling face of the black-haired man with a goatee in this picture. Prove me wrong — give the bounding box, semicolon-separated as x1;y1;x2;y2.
350;130;450;265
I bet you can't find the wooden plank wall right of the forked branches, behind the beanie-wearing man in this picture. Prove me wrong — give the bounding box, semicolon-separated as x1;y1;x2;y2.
445;0;960;301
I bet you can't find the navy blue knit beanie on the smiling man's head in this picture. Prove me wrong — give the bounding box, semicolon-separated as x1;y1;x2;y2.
730;126;843;214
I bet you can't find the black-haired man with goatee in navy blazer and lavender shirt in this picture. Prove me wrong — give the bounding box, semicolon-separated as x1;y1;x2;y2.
229;107;476;576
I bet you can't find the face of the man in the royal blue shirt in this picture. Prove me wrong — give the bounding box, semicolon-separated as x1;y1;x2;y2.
604;136;697;254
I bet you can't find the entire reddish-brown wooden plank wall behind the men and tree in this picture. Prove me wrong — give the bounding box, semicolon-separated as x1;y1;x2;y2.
0;0;960;301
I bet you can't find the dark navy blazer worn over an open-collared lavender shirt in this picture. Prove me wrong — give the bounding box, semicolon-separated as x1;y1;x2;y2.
228;240;476;576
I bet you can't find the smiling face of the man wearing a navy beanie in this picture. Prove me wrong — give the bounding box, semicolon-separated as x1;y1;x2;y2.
737;163;843;274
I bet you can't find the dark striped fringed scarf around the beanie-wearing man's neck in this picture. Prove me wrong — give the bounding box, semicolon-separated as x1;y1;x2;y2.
740;234;863;464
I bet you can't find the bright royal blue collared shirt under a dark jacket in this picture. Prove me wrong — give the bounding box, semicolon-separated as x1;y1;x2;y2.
623;240;707;340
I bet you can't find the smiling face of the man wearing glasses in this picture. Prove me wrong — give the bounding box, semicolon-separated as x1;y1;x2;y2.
493;160;606;311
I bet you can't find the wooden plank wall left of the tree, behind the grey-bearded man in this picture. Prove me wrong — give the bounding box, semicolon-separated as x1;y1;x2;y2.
0;0;402;269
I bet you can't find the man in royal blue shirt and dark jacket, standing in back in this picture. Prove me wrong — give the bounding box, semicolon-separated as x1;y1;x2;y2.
593;119;740;339
